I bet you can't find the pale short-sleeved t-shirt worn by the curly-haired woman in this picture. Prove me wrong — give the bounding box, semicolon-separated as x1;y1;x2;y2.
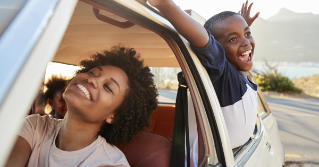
19;115;130;167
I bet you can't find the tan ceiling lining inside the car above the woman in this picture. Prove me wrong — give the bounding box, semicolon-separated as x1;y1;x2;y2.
53;1;179;67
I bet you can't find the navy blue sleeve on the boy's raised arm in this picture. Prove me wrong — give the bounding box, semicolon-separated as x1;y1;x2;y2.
192;31;227;82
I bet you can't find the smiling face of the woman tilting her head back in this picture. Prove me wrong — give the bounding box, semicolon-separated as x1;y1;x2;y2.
63;66;129;124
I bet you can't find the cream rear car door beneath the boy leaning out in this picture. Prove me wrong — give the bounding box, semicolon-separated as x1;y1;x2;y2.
230;74;284;166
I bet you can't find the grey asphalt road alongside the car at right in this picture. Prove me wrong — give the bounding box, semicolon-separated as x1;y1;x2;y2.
266;97;319;163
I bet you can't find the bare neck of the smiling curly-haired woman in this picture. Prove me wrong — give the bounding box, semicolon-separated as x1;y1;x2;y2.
55;113;100;151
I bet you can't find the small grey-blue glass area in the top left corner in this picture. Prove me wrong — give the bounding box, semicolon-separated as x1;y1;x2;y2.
0;0;27;36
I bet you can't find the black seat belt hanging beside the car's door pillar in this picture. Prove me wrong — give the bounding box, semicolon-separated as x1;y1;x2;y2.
170;72;190;167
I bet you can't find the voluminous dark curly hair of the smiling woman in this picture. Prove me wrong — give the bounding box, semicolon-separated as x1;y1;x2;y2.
77;45;158;144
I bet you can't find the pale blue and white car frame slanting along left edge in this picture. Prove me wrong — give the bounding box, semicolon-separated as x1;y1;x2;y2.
0;0;77;166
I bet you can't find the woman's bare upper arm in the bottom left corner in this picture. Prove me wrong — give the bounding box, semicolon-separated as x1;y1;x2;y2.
6;136;31;167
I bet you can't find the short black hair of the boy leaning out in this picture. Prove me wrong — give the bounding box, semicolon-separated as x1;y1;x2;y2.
204;11;239;35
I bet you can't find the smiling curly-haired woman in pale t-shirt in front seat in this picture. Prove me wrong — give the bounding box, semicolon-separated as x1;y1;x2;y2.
7;46;157;167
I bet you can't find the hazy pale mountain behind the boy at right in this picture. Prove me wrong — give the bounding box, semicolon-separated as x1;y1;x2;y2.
251;8;319;63
